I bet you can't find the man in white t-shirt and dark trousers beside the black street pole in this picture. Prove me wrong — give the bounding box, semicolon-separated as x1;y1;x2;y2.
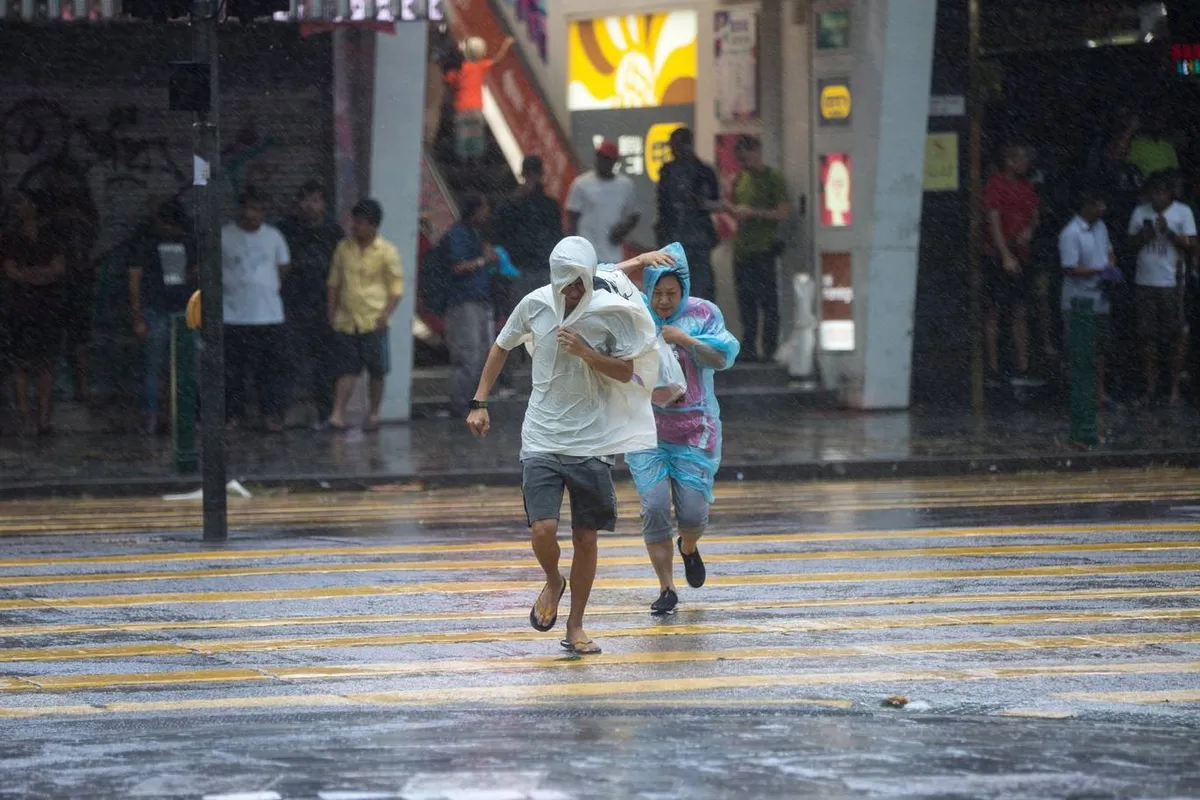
221;188;292;433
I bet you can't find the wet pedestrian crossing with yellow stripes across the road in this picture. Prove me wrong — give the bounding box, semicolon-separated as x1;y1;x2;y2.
0;471;1200;734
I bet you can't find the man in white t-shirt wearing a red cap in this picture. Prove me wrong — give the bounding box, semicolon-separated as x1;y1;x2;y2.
566;142;642;264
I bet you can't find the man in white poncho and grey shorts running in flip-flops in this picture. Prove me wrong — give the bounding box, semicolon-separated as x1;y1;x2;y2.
467;236;661;655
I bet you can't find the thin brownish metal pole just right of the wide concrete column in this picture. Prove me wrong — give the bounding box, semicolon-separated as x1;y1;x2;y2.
967;0;984;421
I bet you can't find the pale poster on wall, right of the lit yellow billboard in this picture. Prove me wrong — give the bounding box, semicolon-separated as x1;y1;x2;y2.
713;7;758;122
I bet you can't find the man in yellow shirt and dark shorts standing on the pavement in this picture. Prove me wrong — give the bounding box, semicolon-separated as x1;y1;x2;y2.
328;199;404;431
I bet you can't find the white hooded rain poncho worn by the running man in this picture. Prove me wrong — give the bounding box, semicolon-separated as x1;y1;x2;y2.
496;236;659;458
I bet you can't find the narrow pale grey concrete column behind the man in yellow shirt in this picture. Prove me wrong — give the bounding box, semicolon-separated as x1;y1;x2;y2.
370;23;428;422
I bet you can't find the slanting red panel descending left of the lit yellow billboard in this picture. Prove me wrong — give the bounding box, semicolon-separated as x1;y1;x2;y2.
451;0;577;204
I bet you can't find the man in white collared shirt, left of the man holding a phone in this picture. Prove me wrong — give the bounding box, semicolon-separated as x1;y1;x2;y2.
1058;191;1118;411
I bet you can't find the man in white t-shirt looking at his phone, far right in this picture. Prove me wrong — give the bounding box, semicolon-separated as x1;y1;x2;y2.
1129;173;1196;405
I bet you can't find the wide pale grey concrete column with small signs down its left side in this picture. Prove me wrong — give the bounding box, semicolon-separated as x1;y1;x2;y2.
812;0;937;409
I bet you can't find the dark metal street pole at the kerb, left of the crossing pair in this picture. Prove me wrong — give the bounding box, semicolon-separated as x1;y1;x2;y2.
192;0;229;542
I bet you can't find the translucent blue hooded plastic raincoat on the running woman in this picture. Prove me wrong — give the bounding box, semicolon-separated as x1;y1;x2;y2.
625;242;740;503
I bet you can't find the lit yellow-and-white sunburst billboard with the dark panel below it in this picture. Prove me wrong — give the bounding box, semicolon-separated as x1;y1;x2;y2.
566;11;698;246
